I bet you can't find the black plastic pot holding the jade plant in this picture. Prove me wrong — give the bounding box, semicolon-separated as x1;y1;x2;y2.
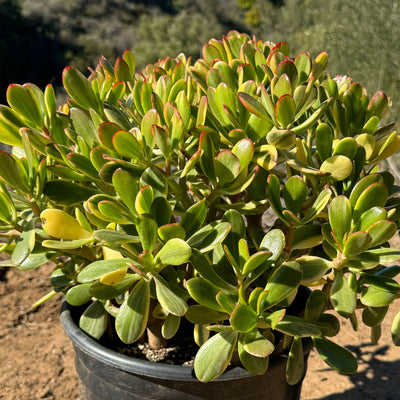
61;301;312;400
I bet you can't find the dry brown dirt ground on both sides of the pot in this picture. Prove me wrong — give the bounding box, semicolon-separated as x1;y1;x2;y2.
0;252;400;400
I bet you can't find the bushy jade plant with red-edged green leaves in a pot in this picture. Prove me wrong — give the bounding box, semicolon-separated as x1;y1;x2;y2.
0;31;400;384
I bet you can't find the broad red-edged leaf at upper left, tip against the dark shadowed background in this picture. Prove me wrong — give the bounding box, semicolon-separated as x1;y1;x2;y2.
63;67;98;110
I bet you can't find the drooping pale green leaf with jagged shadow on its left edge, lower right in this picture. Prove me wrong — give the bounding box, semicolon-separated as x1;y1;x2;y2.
330;272;357;318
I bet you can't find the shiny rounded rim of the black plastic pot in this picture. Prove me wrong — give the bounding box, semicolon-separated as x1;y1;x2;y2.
60;299;312;382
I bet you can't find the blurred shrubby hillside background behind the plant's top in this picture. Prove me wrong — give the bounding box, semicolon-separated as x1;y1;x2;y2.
0;0;400;178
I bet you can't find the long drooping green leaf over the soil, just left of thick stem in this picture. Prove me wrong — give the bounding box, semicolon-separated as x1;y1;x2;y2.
115;279;150;344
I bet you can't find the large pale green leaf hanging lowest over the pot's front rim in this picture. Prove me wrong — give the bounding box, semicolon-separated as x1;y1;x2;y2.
194;331;238;382
